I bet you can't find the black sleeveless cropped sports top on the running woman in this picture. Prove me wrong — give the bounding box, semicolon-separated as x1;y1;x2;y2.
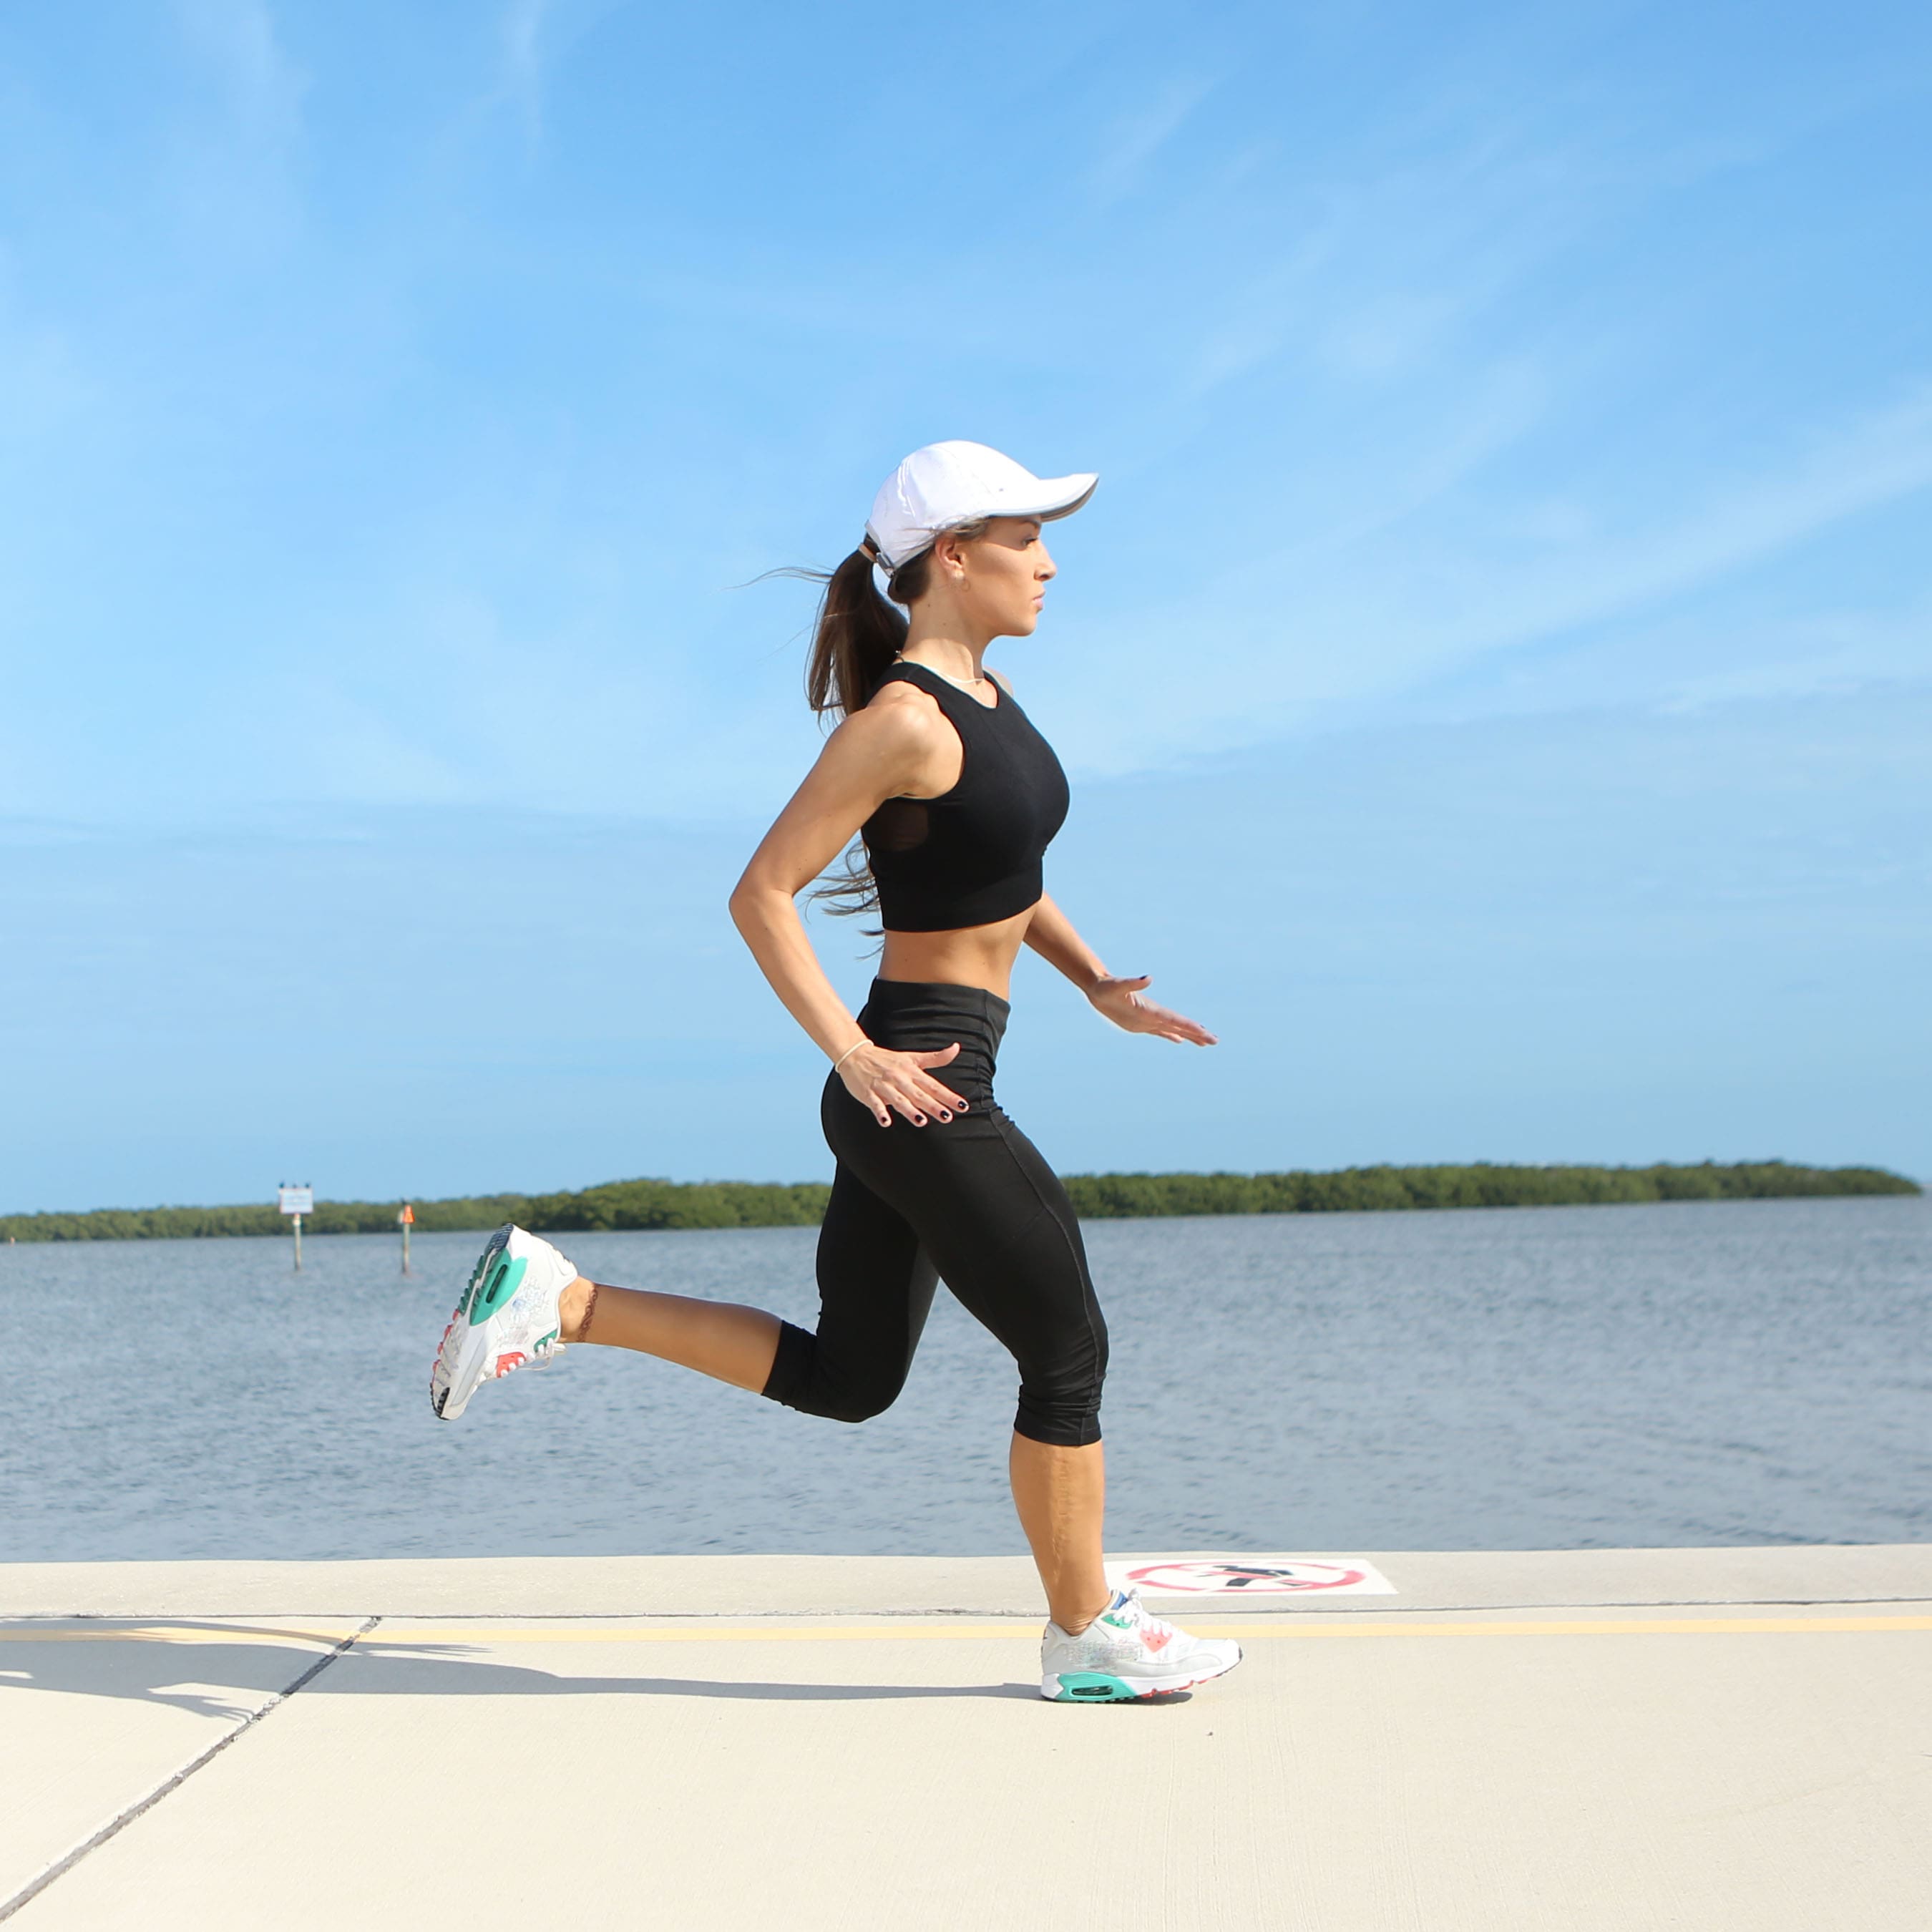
860;659;1066;933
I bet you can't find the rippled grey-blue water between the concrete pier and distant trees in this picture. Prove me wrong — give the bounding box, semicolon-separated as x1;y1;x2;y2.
0;1200;1932;1559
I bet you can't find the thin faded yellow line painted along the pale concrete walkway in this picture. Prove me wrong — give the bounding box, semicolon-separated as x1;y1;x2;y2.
0;1617;1932;1654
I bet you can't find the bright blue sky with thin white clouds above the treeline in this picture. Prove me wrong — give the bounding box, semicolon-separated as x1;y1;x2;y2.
0;0;1932;1209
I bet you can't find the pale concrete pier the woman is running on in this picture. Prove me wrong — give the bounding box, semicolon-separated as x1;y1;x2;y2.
0;1546;1932;1932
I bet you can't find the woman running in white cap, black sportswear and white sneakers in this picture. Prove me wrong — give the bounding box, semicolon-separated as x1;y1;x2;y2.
431;442;1240;1702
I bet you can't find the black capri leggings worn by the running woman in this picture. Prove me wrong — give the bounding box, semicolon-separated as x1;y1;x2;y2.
765;980;1107;1447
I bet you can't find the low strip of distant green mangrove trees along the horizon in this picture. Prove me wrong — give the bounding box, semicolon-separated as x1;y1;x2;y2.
0;1161;1923;1240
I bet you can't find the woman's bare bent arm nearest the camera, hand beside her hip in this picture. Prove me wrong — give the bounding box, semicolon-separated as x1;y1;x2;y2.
731;703;966;1126
